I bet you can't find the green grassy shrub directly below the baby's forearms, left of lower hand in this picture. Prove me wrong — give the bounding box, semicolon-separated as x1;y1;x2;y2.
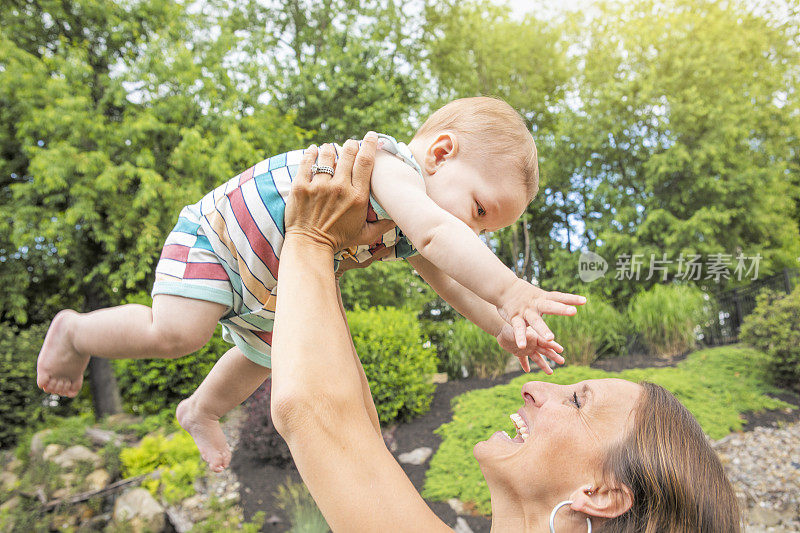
444;319;510;378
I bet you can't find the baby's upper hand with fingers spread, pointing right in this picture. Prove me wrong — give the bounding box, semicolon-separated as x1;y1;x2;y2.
497;279;586;349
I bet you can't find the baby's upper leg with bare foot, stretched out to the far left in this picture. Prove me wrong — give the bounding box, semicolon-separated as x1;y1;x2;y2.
36;294;227;397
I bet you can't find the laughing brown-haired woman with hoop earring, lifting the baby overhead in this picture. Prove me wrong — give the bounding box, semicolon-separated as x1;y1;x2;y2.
271;135;739;533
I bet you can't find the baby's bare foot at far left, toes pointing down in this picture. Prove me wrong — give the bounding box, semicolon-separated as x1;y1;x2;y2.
36;309;89;398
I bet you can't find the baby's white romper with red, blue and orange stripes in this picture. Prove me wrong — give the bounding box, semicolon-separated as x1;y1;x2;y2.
152;134;422;367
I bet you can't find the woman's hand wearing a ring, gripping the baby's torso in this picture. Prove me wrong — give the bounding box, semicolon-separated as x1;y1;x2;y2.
285;132;394;252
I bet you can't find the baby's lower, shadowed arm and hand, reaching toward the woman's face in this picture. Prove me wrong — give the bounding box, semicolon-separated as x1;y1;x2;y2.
408;251;564;374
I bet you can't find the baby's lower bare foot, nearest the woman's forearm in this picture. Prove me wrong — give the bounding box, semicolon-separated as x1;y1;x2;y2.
175;396;231;472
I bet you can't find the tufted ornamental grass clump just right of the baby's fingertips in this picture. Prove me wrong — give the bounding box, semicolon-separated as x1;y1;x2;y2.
545;297;629;365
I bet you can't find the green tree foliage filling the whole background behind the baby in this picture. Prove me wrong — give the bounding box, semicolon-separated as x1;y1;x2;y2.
0;0;800;424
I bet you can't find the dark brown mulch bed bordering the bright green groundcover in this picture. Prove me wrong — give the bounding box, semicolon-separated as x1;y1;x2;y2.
231;354;800;533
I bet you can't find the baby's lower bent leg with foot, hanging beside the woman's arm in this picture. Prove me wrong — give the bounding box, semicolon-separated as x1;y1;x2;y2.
175;348;271;472
